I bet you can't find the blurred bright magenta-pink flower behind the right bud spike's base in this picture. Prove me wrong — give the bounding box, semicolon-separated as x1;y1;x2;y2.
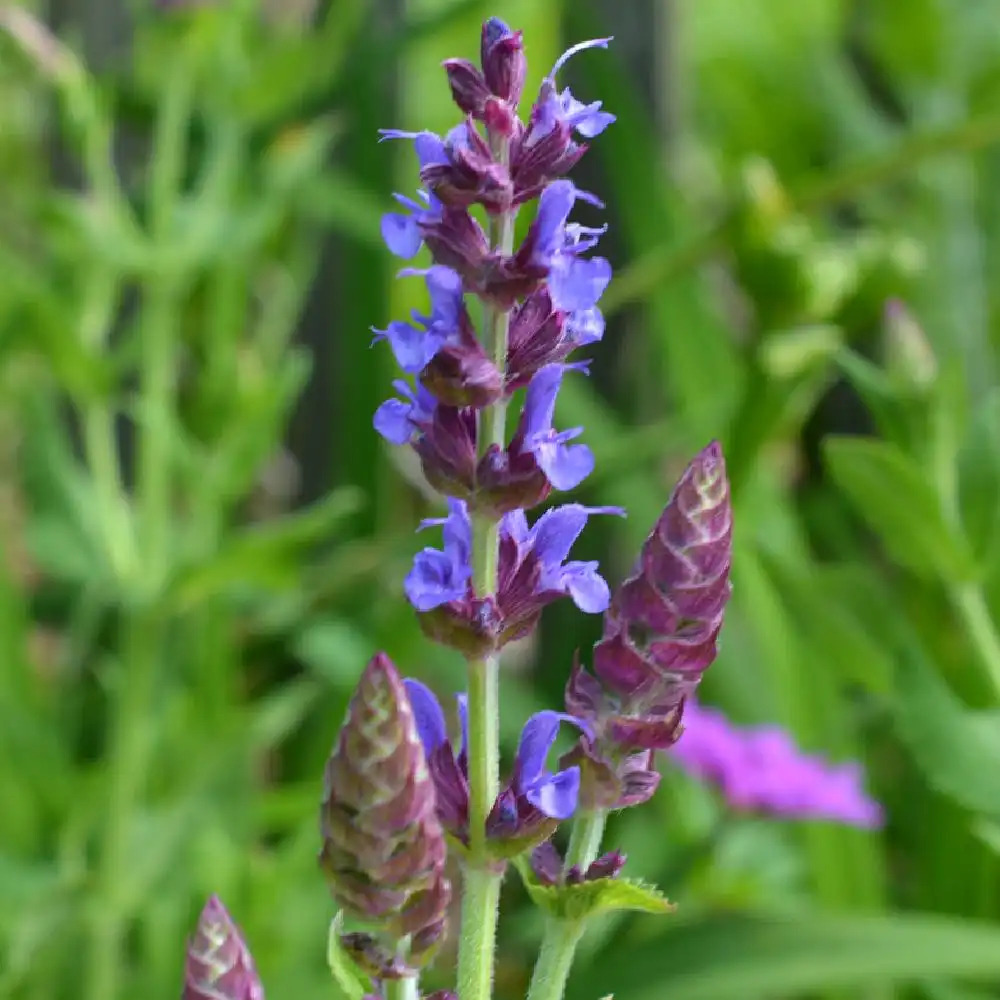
670;699;883;828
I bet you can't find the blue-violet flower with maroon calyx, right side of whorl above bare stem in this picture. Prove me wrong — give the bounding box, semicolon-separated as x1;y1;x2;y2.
499;503;625;618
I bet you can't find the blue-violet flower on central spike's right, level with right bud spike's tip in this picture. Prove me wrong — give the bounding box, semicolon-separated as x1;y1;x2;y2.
517;364;594;490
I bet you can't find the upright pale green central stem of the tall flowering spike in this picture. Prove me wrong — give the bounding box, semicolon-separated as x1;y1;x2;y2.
458;135;514;1000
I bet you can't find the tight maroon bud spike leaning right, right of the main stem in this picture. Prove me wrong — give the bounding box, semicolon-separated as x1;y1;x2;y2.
566;442;732;809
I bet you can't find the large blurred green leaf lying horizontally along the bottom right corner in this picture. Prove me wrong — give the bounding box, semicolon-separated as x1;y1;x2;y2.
566;913;1000;1000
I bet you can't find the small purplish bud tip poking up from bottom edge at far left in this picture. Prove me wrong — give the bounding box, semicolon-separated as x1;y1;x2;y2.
182;896;264;1000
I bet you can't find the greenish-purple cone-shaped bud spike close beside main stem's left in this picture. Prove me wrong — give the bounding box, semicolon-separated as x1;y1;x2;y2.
320;653;451;979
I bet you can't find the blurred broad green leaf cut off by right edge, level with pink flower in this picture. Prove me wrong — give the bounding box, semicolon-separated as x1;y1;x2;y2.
896;649;1000;817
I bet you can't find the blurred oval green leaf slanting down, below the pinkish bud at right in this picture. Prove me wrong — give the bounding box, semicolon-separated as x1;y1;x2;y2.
824;437;975;580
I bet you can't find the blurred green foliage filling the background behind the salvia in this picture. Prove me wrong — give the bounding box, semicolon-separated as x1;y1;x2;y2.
0;0;1000;1000
